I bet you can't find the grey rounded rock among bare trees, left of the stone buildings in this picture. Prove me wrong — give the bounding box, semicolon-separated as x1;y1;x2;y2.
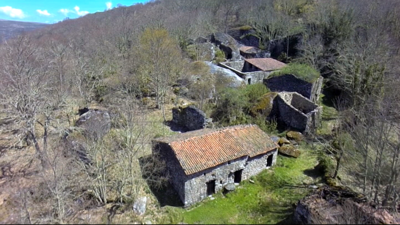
76;107;111;139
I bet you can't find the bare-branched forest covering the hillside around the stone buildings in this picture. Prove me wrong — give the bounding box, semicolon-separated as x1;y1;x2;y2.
0;0;400;223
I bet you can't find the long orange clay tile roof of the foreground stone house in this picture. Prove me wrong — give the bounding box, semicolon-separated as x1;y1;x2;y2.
155;125;278;175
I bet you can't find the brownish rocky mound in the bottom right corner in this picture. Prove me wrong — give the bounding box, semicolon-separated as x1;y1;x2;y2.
294;186;396;224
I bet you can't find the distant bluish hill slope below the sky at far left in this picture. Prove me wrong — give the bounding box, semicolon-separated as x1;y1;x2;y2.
0;20;48;41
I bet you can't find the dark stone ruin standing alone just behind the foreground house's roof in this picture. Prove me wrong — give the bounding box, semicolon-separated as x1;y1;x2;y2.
172;106;212;131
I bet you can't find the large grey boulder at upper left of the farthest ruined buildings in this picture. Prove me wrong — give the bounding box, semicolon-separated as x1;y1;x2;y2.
211;32;241;60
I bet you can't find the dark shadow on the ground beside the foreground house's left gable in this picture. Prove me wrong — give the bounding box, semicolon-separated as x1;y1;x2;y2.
139;155;183;207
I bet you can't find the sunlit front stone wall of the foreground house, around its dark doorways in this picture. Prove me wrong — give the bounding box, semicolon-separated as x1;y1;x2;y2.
182;150;278;207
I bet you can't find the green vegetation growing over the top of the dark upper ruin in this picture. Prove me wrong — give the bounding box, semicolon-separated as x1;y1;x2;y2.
269;63;320;83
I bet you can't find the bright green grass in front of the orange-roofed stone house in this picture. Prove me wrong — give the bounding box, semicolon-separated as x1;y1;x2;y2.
162;147;317;224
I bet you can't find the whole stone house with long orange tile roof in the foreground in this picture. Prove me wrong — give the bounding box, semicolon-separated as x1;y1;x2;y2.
153;125;279;207
